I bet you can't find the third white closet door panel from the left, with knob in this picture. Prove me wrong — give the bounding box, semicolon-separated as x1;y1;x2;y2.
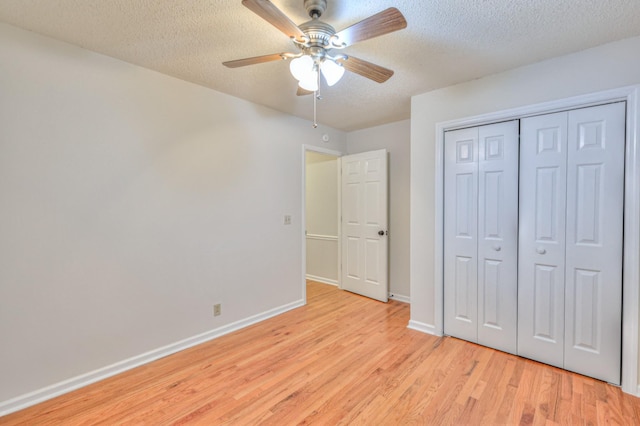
518;112;567;368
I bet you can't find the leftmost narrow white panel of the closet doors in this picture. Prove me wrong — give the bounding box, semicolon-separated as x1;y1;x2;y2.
444;128;478;342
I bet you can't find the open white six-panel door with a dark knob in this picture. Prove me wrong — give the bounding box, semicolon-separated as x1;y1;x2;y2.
341;149;389;302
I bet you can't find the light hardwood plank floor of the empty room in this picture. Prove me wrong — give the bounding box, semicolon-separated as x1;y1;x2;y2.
0;282;640;425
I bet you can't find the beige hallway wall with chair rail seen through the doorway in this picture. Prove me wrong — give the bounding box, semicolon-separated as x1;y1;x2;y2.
305;151;339;284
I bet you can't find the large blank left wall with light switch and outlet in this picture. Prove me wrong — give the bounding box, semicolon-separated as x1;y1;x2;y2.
0;24;346;411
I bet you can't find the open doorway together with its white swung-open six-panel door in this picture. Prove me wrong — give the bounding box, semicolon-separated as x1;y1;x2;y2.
302;146;389;302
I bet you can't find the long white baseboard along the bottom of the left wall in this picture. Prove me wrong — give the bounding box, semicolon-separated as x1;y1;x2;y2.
0;300;304;417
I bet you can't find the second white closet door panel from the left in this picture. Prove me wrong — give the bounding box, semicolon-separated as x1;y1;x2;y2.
478;121;519;353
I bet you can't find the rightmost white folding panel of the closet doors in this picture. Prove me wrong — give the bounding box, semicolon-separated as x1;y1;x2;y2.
564;103;625;384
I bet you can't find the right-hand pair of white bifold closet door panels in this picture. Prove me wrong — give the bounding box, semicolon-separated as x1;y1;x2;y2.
518;103;625;384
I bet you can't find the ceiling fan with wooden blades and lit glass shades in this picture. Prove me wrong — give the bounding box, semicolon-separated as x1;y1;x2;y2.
223;0;407;105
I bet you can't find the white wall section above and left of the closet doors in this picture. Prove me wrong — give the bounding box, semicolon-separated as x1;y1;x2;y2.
411;37;640;370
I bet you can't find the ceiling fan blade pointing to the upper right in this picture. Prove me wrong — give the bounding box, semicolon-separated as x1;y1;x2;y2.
334;7;407;46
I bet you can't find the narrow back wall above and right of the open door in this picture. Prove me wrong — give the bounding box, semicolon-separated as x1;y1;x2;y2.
347;120;413;302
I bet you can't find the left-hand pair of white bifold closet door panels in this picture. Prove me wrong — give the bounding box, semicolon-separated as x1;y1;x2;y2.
444;121;518;353
